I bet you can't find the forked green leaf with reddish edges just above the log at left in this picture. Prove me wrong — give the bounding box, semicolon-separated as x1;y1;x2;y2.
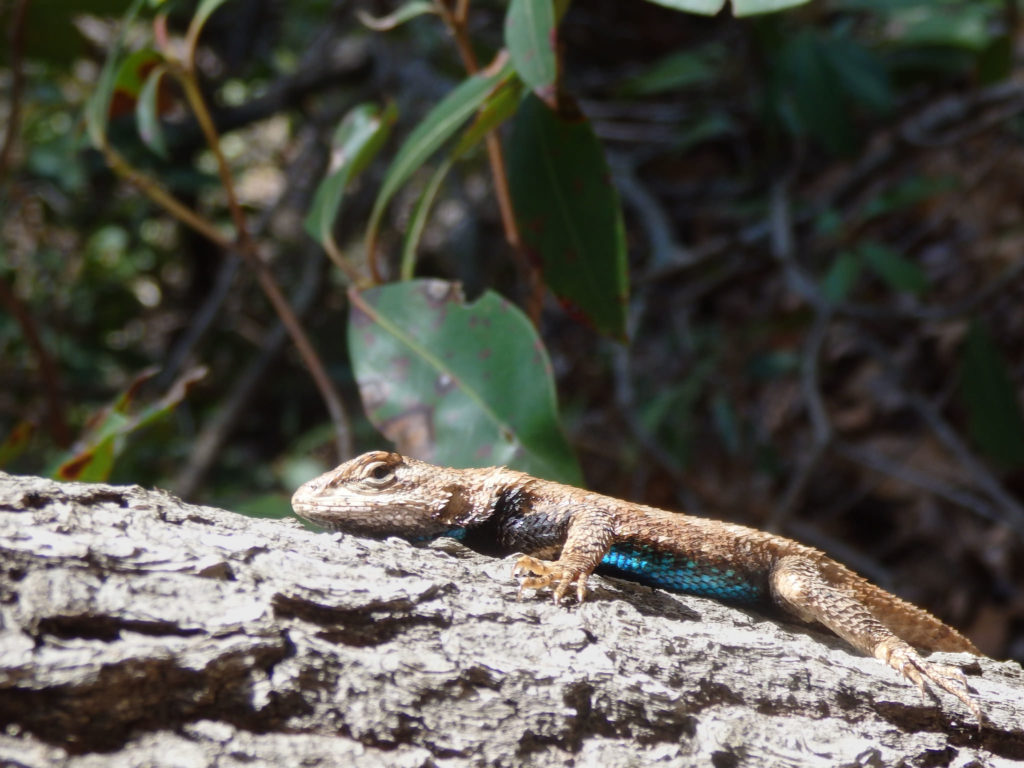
47;366;207;482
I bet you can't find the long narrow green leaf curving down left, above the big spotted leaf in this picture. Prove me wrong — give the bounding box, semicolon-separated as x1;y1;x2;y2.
366;65;512;257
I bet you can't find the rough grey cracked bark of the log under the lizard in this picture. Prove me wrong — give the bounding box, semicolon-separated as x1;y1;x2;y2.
0;473;1024;768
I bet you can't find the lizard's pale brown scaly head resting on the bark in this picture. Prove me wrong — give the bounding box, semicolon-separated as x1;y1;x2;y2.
292;451;472;541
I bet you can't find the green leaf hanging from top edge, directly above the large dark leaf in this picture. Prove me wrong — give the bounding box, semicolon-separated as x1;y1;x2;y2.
505;0;558;91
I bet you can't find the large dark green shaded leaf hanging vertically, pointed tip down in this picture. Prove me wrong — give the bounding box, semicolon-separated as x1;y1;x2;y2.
508;94;629;339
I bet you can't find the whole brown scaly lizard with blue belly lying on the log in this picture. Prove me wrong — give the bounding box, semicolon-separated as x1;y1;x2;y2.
292;451;983;726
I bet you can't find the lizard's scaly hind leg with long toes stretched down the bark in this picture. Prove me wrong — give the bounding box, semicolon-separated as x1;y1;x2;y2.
769;555;982;725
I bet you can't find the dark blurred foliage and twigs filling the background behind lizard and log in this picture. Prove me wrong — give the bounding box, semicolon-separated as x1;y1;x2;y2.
0;0;1024;656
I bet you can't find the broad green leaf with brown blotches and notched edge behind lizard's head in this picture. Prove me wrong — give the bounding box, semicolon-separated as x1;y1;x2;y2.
348;280;582;485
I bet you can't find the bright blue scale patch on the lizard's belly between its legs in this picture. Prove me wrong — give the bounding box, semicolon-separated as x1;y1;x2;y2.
601;544;764;603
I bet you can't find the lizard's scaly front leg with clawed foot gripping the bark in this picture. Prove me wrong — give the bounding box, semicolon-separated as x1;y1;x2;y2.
513;509;614;603
